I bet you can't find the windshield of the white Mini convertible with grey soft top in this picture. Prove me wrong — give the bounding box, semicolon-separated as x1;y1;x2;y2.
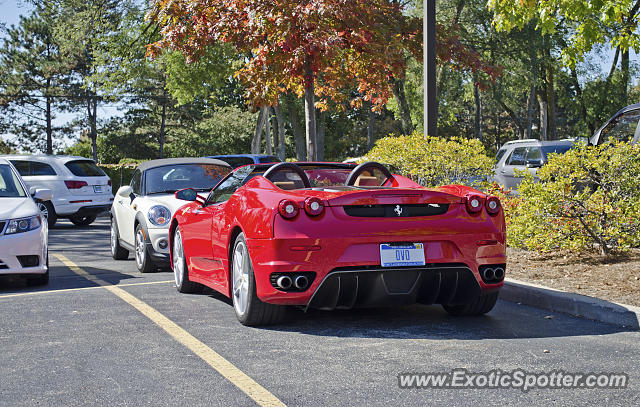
144;163;231;195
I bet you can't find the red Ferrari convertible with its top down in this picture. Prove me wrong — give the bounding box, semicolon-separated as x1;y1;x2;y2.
169;162;505;325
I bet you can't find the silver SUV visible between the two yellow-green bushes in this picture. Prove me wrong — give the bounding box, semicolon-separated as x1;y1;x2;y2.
494;139;576;190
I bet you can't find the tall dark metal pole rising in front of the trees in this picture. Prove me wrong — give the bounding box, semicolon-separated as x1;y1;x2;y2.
423;0;438;137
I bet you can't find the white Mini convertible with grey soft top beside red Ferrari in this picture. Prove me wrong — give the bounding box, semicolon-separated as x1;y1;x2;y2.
111;158;231;273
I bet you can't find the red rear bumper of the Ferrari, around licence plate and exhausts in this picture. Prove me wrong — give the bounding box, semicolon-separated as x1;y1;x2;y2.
247;233;506;309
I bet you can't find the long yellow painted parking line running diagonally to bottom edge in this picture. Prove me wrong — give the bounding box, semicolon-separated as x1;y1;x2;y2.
54;254;285;406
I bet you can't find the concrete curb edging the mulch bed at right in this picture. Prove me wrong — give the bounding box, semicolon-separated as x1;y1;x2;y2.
500;279;640;330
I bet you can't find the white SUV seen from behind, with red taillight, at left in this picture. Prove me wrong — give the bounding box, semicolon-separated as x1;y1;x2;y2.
3;155;113;227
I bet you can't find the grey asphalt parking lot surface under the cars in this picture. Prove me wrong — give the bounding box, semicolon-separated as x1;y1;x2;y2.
0;218;640;406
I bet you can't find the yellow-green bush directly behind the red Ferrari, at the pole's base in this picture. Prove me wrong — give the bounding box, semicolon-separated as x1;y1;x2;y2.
367;132;493;187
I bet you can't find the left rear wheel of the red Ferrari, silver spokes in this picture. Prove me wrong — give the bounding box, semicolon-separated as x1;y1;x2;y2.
231;233;285;326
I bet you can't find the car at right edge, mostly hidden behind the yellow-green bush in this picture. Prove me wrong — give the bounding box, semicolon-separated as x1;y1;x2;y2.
589;103;640;146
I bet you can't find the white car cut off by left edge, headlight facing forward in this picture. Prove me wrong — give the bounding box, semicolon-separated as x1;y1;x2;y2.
0;158;52;285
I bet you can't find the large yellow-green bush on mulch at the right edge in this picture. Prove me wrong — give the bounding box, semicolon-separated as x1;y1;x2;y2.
507;143;640;256
